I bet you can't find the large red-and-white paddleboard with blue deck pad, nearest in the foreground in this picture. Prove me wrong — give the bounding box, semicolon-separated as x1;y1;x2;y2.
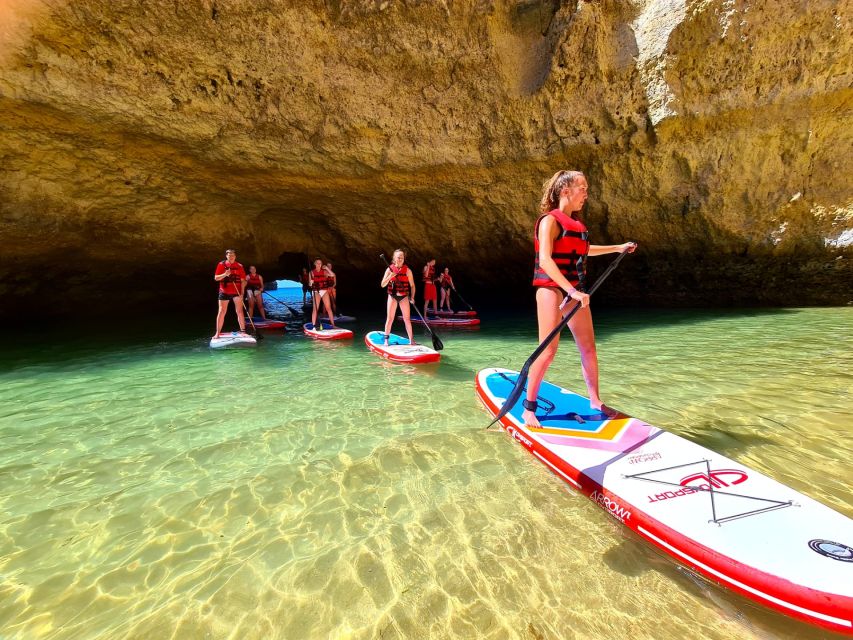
476;369;853;634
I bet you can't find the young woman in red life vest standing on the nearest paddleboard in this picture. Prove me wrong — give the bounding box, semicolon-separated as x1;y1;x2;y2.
522;171;637;427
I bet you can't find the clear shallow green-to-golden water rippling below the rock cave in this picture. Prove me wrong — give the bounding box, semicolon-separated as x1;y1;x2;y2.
0;300;853;640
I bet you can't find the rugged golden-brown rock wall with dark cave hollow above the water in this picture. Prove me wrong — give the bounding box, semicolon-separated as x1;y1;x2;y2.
0;0;853;313
